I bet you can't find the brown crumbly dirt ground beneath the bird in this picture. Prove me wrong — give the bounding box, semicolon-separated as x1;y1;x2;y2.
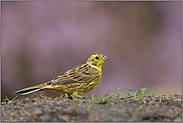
1;95;182;122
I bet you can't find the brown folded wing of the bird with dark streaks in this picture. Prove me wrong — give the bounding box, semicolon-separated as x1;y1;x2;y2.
47;64;98;84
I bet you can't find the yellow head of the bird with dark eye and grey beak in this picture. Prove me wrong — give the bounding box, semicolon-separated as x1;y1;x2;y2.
87;53;109;69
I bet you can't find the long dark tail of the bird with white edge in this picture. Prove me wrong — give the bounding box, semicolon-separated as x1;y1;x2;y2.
15;86;44;95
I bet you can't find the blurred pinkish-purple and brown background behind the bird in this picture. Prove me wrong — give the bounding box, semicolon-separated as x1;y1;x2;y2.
1;1;182;99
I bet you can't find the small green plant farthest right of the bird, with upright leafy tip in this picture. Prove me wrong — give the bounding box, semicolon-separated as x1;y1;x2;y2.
127;87;152;99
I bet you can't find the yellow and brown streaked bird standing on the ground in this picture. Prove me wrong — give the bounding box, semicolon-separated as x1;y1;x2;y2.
14;53;109;97
